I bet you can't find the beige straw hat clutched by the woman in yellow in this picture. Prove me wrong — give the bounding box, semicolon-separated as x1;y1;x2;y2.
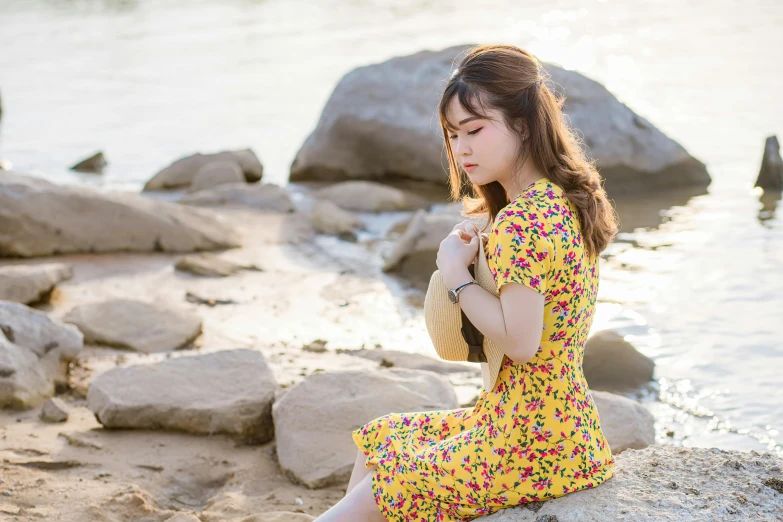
424;225;503;390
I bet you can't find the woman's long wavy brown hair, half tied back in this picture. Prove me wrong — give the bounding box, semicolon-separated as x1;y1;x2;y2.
438;45;618;256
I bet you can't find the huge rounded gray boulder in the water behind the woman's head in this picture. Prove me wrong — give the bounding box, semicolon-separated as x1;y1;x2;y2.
290;46;710;194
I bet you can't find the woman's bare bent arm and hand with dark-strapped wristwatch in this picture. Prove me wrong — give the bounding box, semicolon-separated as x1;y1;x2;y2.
441;264;544;364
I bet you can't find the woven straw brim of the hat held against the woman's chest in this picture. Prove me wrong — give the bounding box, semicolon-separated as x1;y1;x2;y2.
424;229;503;390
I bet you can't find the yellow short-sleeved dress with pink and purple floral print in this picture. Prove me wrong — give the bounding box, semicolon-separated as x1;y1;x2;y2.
352;178;614;522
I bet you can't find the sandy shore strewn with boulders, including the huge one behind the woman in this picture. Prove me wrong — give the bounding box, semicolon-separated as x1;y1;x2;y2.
0;49;783;522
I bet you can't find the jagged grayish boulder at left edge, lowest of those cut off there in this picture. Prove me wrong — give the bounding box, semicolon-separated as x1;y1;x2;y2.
0;301;84;409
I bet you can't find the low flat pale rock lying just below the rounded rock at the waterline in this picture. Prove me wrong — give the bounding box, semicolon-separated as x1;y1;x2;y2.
179;183;294;213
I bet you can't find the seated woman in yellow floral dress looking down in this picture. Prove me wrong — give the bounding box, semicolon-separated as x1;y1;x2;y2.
318;45;617;522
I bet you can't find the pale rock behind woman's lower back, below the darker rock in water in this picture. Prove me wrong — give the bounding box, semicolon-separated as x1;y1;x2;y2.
590;390;655;455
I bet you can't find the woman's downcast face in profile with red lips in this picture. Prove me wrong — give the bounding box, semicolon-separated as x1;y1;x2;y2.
447;96;519;187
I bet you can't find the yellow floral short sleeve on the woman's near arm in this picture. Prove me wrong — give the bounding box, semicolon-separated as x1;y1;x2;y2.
487;207;554;295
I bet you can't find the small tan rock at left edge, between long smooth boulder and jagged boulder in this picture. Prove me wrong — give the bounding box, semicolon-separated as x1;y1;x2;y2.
0;263;73;304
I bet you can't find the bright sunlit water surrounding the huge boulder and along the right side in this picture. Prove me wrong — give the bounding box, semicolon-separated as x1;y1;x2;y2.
0;0;783;453
